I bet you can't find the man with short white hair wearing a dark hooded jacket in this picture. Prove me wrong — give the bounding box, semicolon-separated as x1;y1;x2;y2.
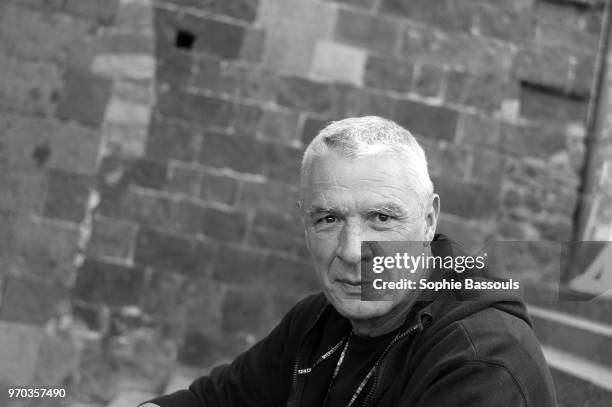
141;117;556;407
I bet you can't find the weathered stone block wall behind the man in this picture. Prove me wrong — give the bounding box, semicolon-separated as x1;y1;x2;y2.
0;0;603;405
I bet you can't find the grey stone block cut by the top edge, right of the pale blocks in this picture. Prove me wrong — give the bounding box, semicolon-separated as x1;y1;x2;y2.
380;0;474;32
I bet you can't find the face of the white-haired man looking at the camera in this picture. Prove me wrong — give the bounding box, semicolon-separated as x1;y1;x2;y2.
302;151;437;321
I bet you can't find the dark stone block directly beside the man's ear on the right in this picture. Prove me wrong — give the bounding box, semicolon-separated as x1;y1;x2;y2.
432;177;500;220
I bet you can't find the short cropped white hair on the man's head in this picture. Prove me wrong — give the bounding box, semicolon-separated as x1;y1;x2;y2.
299;116;433;211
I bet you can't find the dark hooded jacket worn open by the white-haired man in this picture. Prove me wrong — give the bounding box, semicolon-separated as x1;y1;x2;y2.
146;239;556;407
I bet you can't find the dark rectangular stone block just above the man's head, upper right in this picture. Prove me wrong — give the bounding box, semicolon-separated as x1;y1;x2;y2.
393;100;458;140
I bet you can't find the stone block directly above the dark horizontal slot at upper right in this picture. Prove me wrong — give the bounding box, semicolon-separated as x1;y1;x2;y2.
513;46;571;91
